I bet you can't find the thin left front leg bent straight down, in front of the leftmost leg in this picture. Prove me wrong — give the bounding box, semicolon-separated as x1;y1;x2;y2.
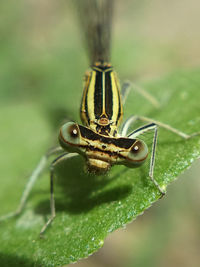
40;153;78;237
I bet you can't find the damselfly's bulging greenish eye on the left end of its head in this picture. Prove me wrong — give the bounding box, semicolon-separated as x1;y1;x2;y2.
60;122;80;145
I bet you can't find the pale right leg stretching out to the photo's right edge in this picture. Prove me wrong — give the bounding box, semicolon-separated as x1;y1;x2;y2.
121;116;200;139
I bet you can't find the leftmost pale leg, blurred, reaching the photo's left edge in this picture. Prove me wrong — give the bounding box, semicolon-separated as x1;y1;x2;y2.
0;147;63;221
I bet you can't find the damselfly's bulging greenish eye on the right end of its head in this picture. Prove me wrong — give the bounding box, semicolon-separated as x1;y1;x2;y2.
128;140;148;164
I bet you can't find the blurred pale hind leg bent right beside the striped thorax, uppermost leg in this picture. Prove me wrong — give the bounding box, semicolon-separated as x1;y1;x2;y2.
121;81;160;108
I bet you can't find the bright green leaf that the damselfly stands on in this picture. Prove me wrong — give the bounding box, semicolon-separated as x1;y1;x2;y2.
0;70;200;266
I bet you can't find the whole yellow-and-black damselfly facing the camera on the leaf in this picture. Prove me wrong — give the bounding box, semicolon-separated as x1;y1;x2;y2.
0;0;199;235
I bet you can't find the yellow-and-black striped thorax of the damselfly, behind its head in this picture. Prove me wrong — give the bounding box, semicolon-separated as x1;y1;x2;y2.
80;63;123;136
